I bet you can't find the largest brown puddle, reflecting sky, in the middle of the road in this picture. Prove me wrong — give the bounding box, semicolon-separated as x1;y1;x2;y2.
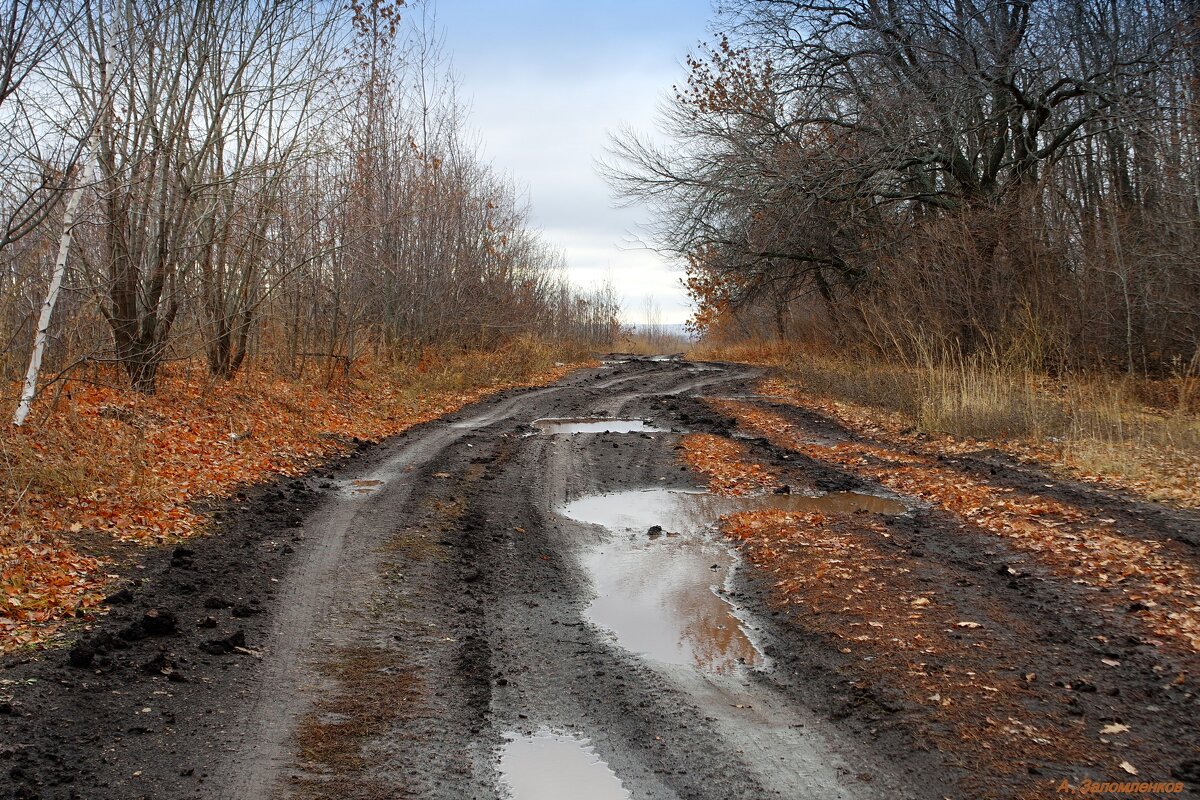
558;489;905;673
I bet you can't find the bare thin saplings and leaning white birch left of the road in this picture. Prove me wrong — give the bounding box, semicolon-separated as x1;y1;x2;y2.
0;0;618;400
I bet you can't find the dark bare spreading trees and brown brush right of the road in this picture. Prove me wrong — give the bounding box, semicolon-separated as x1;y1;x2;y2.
608;0;1200;373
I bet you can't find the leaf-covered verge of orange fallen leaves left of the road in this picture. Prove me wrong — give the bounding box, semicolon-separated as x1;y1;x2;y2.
0;341;590;652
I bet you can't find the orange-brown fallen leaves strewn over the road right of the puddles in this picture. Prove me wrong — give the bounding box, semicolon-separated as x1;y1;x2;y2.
679;401;1196;796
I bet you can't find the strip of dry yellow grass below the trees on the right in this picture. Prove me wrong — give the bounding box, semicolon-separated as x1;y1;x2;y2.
697;343;1200;507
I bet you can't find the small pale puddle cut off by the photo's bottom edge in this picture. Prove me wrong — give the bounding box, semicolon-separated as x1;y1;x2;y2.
500;730;631;800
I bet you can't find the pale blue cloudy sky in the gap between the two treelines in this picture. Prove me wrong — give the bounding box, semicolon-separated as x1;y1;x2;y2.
432;0;712;323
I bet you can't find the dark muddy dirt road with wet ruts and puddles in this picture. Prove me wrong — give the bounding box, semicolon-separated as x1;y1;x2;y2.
0;359;1198;800
